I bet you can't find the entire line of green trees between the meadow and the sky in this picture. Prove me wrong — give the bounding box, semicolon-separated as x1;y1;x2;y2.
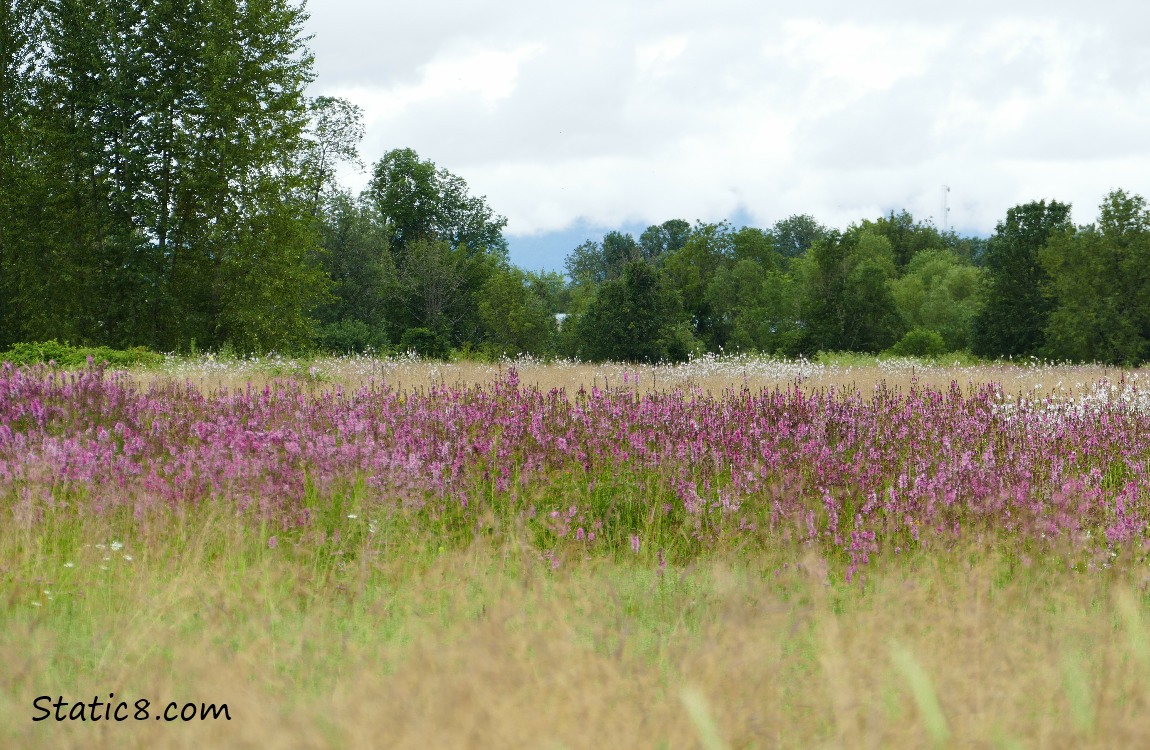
0;0;1150;363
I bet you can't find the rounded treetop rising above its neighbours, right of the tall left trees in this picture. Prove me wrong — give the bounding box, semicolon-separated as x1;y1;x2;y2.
367;148;507;261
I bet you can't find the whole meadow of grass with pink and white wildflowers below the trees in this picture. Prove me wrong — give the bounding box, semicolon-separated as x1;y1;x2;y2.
0;358;1150;750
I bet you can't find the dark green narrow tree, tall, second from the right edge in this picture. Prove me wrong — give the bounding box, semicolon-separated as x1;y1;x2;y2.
973;200;1072;357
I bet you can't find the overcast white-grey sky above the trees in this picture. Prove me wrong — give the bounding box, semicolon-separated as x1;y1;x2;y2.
306;0;1150;270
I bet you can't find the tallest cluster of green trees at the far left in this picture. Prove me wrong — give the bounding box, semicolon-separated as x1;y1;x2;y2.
0;0;324;351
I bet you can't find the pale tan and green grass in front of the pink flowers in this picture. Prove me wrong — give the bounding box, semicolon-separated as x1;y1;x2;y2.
0;494;1150;749
